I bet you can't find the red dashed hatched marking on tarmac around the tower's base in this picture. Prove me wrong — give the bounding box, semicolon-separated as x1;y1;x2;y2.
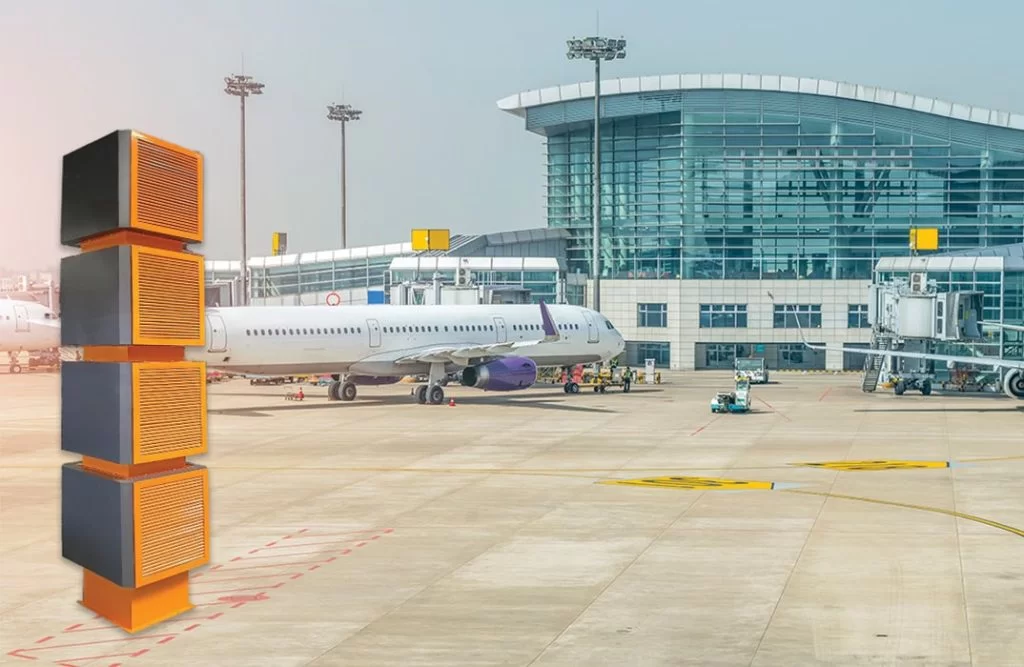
7;528;394;667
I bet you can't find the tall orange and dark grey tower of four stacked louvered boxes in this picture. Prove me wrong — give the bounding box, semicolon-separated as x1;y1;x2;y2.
60;130;210;632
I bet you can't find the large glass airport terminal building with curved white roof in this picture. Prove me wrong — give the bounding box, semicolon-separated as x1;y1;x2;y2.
499;74;1024;370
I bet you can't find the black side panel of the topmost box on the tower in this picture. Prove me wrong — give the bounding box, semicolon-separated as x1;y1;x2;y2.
60;130;131;246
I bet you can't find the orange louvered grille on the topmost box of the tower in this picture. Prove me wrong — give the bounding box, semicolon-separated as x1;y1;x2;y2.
132;134;203;242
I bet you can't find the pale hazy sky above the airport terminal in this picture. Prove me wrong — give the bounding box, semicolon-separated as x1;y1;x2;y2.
0;0;1024;269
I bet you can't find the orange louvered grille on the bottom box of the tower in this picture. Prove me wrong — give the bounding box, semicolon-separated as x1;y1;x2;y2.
135;469;208;585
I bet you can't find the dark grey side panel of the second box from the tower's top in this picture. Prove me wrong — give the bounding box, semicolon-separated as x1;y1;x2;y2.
60;246;132;345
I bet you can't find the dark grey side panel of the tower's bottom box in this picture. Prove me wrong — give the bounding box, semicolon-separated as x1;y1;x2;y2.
60;463;135;586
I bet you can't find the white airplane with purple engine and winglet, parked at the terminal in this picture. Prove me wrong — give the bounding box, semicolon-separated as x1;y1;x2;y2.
186;302;626;405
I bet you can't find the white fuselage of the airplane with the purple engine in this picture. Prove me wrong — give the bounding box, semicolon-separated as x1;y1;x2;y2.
187;304;625;377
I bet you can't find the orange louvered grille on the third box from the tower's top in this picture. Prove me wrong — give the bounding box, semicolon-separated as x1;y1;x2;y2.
133;362;206;463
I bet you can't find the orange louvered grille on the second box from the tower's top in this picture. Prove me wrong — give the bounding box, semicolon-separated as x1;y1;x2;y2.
132;246;206;345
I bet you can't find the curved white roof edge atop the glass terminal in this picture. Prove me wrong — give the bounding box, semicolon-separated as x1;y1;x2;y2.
498;74;1024;130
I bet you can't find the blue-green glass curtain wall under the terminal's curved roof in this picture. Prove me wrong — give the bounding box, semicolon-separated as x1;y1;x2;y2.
525;88;1024;280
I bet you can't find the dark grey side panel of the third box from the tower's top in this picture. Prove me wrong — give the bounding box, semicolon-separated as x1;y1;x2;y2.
60;362;134;465
